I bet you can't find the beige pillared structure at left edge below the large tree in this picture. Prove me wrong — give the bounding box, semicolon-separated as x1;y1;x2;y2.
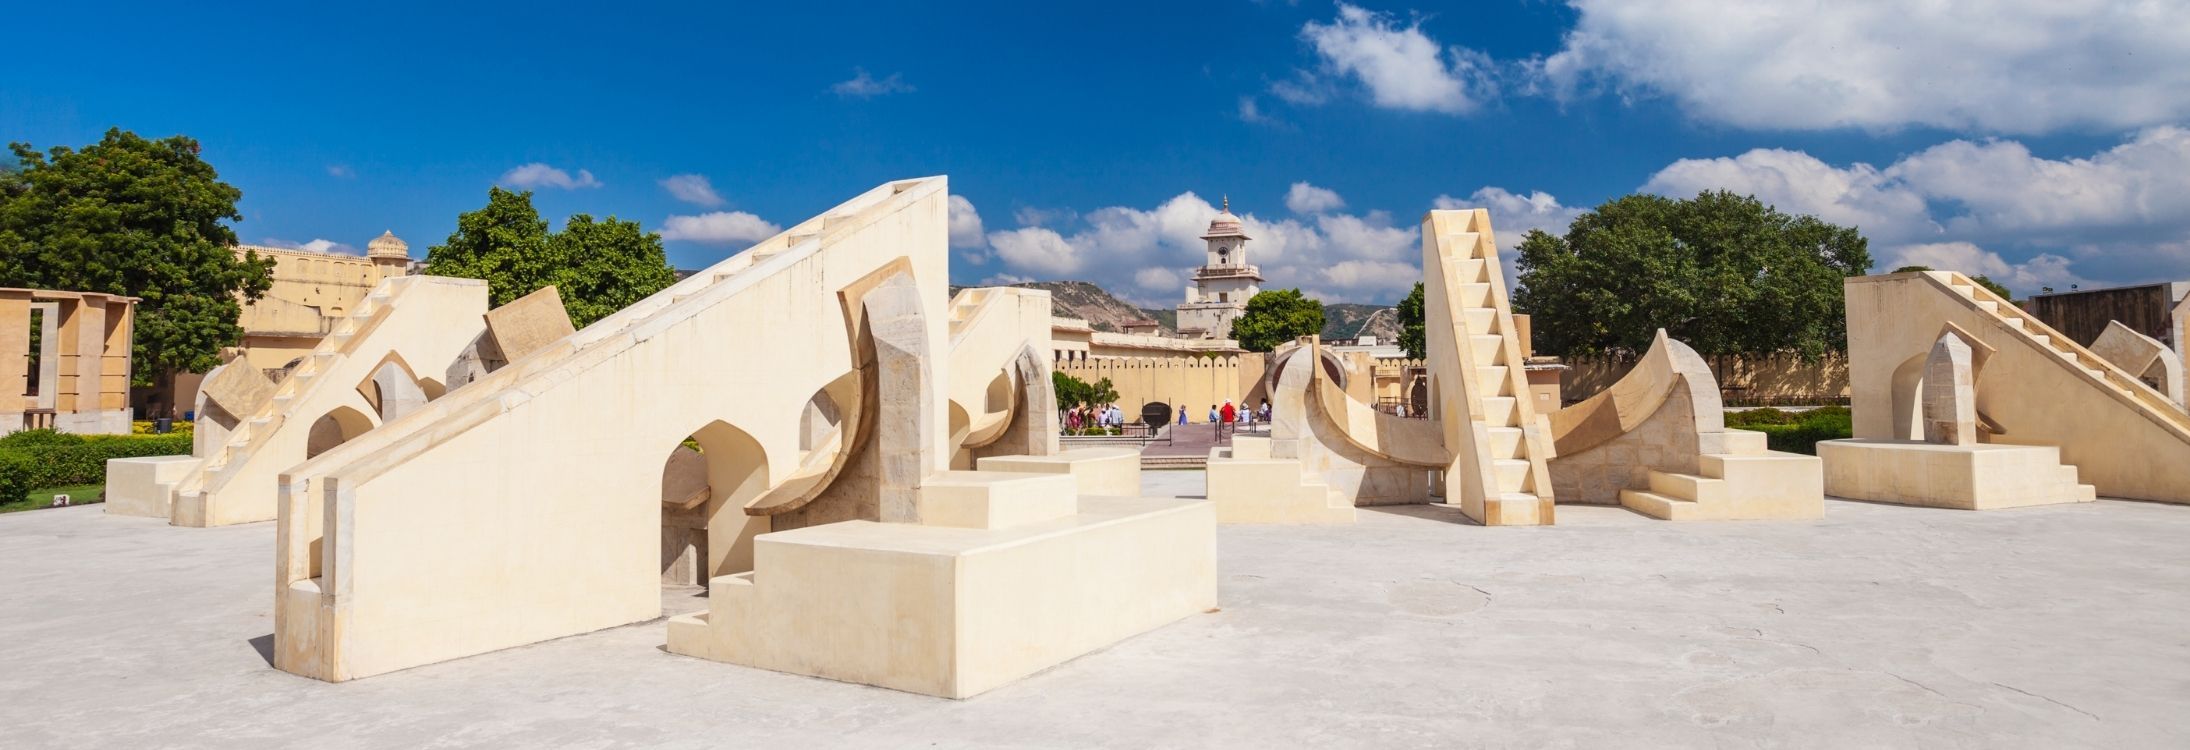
0;289;138;434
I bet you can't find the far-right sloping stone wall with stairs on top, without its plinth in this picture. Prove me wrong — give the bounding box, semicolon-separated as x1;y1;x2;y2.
1829;272;2190;502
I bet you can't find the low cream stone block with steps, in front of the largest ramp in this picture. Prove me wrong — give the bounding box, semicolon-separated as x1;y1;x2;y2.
668;498;1218;697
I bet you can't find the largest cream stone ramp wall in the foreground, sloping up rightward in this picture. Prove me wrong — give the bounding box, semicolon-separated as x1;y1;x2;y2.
276;178;948;680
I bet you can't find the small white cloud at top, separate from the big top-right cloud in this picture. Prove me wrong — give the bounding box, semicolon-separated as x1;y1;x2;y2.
1305;2;1496;114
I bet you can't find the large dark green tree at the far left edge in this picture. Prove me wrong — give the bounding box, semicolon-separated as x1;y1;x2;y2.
0;127;274;384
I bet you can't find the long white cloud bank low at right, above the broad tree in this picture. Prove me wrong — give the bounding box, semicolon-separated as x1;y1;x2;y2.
1643;127;2190;294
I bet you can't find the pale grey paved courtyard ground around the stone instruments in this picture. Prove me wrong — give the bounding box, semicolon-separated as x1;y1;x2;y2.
0;471;2190;748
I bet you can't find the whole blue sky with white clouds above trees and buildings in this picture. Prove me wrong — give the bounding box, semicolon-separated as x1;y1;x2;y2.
0;0;2190;305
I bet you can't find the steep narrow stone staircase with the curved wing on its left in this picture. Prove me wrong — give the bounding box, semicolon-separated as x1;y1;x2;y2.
1209;208;1553;526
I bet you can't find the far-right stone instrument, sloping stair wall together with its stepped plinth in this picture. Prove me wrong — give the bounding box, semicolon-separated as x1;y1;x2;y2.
1818;272;2163;509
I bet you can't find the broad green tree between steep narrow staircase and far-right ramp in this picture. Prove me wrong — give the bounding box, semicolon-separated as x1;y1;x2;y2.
1513;191;1870;357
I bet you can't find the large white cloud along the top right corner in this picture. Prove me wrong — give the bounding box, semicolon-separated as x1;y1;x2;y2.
1533;0;2190;134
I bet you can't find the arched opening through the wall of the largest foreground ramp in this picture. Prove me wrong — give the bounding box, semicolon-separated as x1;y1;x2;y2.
661;419;770;610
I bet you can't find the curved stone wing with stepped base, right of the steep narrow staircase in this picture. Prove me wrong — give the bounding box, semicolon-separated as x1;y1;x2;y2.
1551;329;1824;520
